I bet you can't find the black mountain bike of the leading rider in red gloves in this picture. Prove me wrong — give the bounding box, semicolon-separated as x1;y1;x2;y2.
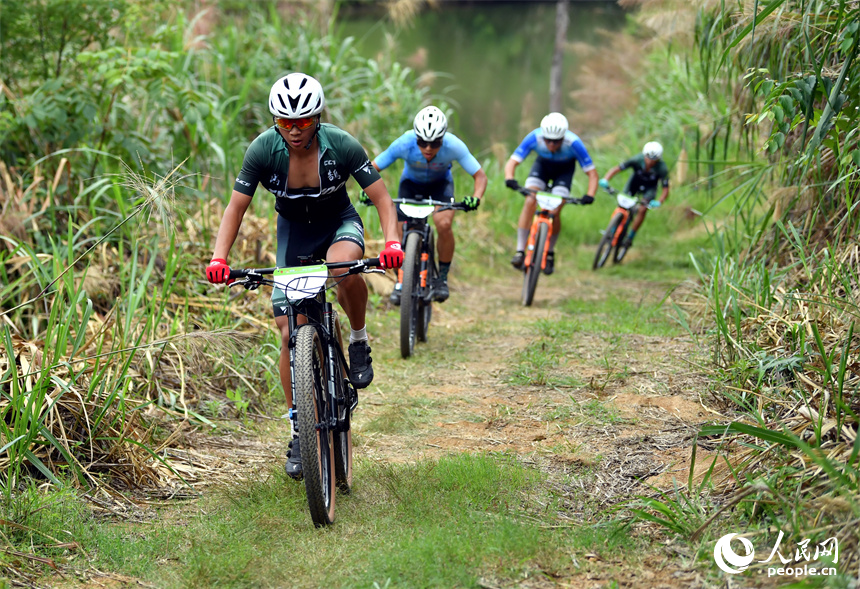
229;258;383;527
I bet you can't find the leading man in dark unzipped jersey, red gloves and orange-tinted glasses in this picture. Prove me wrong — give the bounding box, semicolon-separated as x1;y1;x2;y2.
206;73;403;478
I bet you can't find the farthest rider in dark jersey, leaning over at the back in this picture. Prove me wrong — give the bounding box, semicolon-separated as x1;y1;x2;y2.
600;141;669;247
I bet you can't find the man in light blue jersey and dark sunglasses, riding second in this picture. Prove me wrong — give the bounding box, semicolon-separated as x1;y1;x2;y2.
373;106;487;305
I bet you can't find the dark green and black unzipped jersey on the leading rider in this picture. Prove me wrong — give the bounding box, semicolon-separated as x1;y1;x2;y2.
233;123;379;222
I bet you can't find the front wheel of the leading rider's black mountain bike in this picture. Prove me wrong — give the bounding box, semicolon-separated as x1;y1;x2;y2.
293;325;335;527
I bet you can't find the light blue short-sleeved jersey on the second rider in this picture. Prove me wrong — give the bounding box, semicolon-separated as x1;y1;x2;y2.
373;131;481;184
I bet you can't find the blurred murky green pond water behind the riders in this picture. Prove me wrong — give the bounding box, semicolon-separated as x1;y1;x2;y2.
338;1;626;152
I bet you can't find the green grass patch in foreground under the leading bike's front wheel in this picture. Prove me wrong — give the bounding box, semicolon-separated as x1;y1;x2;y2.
28;454;630;588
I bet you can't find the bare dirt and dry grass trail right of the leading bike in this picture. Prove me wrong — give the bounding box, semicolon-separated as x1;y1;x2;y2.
355;271;718;499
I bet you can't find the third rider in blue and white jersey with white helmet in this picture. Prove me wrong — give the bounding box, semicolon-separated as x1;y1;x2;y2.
505;112;599;274
